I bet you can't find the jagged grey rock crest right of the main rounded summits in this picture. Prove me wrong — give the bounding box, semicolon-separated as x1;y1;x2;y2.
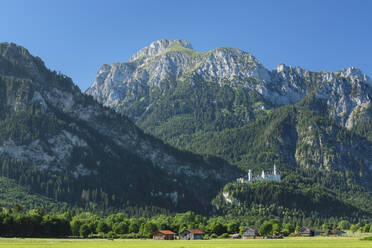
277;65;372;129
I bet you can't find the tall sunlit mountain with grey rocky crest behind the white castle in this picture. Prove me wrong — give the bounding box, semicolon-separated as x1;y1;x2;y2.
85;39;372;217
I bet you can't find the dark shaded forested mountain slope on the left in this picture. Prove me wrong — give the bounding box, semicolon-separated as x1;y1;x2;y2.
0;43;239;212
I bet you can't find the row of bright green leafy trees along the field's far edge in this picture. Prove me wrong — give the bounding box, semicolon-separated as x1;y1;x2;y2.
0;205;372;238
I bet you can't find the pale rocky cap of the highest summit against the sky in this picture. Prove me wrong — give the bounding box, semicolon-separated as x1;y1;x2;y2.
129;39;193;62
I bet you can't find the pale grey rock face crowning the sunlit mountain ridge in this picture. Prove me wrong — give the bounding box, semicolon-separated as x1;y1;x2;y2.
86;39;372;129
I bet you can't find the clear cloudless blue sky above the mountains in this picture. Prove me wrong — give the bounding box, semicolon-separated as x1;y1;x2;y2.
0;0;372;90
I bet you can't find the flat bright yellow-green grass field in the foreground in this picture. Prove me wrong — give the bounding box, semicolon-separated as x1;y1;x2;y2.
0;237;372;248
